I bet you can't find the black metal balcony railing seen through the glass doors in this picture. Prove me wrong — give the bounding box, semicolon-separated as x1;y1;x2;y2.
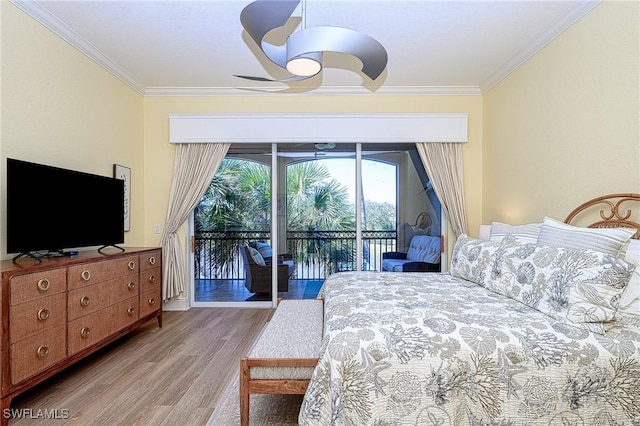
194;231;396;280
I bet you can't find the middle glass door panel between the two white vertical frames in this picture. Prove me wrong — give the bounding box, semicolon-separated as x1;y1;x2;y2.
279;143;356;298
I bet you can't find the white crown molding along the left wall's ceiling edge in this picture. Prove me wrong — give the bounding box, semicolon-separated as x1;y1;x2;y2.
9;0;145;95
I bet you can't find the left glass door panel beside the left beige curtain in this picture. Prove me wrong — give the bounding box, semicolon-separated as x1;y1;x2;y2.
192;145;272;306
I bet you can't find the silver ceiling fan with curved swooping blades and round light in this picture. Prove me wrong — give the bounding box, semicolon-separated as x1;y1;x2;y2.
235;0;388;82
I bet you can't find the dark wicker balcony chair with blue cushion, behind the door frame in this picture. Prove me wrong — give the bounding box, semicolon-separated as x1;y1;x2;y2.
238;244;290;294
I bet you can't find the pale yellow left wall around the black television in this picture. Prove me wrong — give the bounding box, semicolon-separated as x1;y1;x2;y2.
0;1;145;258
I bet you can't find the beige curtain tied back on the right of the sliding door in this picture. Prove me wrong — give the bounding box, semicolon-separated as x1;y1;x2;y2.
416;142;469;236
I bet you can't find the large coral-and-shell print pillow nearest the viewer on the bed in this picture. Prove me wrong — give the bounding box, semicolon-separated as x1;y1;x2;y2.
485;239;635;334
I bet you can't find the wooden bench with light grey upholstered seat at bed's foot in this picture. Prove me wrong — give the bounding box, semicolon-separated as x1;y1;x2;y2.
239;299;324;426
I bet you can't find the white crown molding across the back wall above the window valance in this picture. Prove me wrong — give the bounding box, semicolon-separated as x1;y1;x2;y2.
144;86;482;97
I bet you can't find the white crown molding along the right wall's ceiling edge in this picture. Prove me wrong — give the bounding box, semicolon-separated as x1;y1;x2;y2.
480;0;601;93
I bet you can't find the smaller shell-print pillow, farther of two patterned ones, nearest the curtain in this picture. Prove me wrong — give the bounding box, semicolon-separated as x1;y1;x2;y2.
449;234;500;285
